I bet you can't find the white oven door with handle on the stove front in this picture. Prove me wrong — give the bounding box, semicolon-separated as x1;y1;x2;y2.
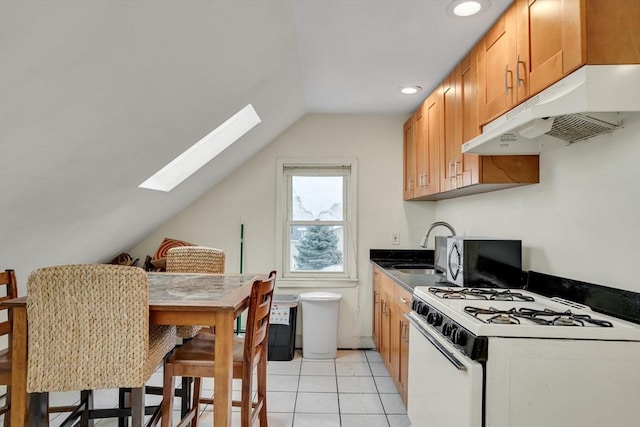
407;318;483;427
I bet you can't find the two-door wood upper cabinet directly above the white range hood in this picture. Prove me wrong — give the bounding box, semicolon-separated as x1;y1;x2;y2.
477;0;640;125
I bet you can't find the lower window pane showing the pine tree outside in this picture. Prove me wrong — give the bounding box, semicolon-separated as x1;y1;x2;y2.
290;225;344;272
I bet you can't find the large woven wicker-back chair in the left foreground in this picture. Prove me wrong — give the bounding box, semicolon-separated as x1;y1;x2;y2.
27;264;175;425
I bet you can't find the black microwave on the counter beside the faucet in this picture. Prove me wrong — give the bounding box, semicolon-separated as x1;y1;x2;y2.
446;236;524;288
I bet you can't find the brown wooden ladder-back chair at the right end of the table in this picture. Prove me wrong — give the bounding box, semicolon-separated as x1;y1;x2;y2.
162;271;276;427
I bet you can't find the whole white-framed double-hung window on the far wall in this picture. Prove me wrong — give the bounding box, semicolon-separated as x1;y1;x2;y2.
278;160;356;279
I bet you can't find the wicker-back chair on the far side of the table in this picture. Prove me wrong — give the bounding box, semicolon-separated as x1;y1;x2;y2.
167;246;225;338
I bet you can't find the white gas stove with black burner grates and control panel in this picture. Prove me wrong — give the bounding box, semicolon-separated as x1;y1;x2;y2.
407;287;640;427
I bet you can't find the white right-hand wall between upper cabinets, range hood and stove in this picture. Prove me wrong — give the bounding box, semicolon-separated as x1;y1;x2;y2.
436;114;640;292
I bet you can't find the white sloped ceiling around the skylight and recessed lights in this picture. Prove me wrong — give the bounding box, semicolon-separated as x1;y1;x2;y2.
0;0;510;281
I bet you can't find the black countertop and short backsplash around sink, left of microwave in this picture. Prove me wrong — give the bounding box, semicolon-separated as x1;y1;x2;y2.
369;249;444;292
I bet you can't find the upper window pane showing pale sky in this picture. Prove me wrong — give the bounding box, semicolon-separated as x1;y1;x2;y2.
291;176;344;221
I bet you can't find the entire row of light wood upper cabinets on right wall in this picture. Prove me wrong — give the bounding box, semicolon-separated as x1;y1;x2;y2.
404;0;640;200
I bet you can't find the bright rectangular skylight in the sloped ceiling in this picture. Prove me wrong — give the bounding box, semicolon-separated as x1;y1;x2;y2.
138;104;262;191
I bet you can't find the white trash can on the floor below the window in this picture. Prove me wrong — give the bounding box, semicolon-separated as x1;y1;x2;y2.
300;292;342;359
